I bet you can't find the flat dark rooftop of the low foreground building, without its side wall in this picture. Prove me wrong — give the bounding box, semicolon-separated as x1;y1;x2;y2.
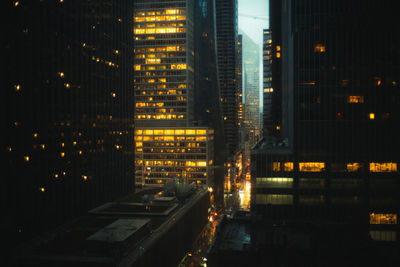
17;188;207;266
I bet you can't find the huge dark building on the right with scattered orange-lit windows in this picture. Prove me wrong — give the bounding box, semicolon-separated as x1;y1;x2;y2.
252;0;400;244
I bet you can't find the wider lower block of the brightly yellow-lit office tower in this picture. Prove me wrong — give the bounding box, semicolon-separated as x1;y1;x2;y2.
135;127;214;185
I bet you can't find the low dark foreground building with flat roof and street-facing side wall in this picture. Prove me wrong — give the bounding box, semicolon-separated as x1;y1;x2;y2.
14;187;210;267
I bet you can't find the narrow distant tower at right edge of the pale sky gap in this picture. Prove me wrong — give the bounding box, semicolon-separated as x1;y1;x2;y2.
262;29;276;138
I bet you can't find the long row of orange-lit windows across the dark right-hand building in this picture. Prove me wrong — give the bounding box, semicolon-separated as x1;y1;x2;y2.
272;162;397;172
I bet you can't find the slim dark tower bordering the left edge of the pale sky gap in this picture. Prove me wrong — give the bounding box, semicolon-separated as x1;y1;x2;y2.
215;0;238;155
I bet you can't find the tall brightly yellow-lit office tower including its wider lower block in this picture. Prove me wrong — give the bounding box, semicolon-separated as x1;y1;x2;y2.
134;0;218;186
